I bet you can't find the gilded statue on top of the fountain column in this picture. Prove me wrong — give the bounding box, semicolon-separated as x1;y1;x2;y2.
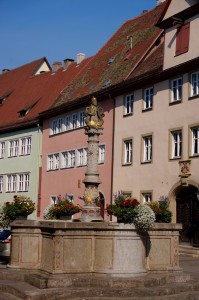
85;97;104;128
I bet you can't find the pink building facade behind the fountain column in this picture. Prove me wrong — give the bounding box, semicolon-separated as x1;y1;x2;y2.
40;98;113;219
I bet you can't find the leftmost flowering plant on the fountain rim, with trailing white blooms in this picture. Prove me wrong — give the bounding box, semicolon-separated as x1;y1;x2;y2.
1;195;36;227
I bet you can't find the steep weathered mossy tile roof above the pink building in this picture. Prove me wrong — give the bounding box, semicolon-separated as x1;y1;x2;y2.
55;2;166;106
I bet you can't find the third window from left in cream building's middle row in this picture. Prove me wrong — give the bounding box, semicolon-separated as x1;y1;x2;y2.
171;130;182;159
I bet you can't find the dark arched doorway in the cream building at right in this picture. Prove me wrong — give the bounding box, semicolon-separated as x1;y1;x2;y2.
176;186;199;247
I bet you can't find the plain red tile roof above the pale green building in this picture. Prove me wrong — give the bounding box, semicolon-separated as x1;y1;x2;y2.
0;58;91;130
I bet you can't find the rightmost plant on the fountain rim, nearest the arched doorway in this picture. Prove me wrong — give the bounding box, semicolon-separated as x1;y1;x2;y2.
148;196;172;223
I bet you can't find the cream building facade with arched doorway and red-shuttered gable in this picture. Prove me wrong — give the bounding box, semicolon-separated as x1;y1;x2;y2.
113;0;199;244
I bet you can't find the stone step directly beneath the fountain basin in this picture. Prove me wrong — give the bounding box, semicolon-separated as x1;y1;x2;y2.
24;272;191;289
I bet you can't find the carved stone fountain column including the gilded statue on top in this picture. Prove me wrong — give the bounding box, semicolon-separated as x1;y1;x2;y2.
80;97;104;222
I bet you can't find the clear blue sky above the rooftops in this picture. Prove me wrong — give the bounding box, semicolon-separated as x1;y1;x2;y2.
0;0;156;73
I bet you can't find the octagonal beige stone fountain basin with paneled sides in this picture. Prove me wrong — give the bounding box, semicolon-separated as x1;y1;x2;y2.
9;220;181;277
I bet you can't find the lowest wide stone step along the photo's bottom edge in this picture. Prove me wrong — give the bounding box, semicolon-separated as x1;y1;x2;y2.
0;276;199;300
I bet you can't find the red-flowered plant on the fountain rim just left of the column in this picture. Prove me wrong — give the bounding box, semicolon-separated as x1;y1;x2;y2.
44;198;81;220
